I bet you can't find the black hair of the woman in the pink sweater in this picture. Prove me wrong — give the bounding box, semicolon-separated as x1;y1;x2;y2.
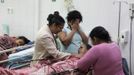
89;26;111;42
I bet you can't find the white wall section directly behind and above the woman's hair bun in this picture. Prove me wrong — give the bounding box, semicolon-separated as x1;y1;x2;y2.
39;0;67;28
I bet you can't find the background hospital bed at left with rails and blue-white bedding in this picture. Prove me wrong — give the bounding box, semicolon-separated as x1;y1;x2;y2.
0;44;34;69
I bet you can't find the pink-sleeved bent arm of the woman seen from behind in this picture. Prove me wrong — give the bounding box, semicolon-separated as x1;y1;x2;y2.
77;48;99;72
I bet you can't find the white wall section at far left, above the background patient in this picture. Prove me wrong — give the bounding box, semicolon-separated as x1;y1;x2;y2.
0;0;35;40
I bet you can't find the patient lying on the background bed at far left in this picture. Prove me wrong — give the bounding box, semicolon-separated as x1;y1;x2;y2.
0;35;30;67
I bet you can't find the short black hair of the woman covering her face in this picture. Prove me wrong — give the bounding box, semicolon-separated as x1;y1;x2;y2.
67;10;82;22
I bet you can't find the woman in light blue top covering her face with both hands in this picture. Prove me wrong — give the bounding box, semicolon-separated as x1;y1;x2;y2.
58;10;88;54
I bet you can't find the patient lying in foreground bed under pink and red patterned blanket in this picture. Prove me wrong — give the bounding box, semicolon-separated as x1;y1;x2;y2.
0;45;91;75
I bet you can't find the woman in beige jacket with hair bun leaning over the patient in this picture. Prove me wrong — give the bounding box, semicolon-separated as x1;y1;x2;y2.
31;12;70;65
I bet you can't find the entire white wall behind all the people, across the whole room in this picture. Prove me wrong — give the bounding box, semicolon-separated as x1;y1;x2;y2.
0;0;134;75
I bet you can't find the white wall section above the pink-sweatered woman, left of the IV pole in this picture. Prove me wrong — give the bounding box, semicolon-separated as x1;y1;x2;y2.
74;0;118;40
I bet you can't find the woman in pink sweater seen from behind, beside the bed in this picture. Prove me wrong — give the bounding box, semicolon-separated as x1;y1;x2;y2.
77;26;124;75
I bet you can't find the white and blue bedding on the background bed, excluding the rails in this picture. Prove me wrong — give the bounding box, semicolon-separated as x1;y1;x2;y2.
7;47;34;69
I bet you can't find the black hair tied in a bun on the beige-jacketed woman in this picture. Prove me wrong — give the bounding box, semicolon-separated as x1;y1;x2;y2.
47;11;65;25
